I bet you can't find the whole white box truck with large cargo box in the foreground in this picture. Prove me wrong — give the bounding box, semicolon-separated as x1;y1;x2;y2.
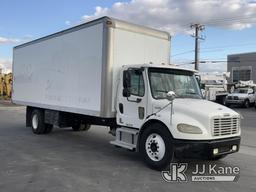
12;17;240;169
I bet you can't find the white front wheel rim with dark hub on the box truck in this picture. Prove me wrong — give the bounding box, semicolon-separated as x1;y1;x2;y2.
145;133;165;161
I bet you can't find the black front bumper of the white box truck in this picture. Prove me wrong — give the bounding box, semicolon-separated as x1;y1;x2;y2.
174;136;241;159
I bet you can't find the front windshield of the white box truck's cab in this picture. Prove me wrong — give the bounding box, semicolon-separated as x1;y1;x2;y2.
149;68;202;99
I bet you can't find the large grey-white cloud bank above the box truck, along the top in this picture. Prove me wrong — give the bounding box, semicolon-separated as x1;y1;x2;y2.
81;0;256;34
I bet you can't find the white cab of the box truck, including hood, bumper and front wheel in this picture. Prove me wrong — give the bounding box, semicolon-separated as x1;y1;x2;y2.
111;64;240;168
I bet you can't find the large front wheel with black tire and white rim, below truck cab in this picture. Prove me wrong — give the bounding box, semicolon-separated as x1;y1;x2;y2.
139;123;174;170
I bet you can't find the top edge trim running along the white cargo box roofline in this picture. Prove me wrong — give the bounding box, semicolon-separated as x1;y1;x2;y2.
14;16;171;49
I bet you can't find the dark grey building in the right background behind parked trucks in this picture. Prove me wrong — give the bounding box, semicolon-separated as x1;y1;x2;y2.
227;52;256;83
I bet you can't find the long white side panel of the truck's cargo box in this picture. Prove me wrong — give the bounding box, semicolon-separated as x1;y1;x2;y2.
12;23;104;116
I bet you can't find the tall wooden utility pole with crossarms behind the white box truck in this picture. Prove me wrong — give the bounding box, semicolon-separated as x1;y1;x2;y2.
190;24;204;70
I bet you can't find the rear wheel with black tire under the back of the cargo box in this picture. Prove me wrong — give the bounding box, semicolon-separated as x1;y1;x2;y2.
31;109;49;134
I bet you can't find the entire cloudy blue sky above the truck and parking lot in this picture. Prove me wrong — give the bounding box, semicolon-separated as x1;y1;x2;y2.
0;0;256;71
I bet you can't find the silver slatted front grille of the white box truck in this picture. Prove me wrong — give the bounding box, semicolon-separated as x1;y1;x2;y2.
213;117;240;136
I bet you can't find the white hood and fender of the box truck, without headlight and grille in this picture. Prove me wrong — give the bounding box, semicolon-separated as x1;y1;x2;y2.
152;98;240;140
